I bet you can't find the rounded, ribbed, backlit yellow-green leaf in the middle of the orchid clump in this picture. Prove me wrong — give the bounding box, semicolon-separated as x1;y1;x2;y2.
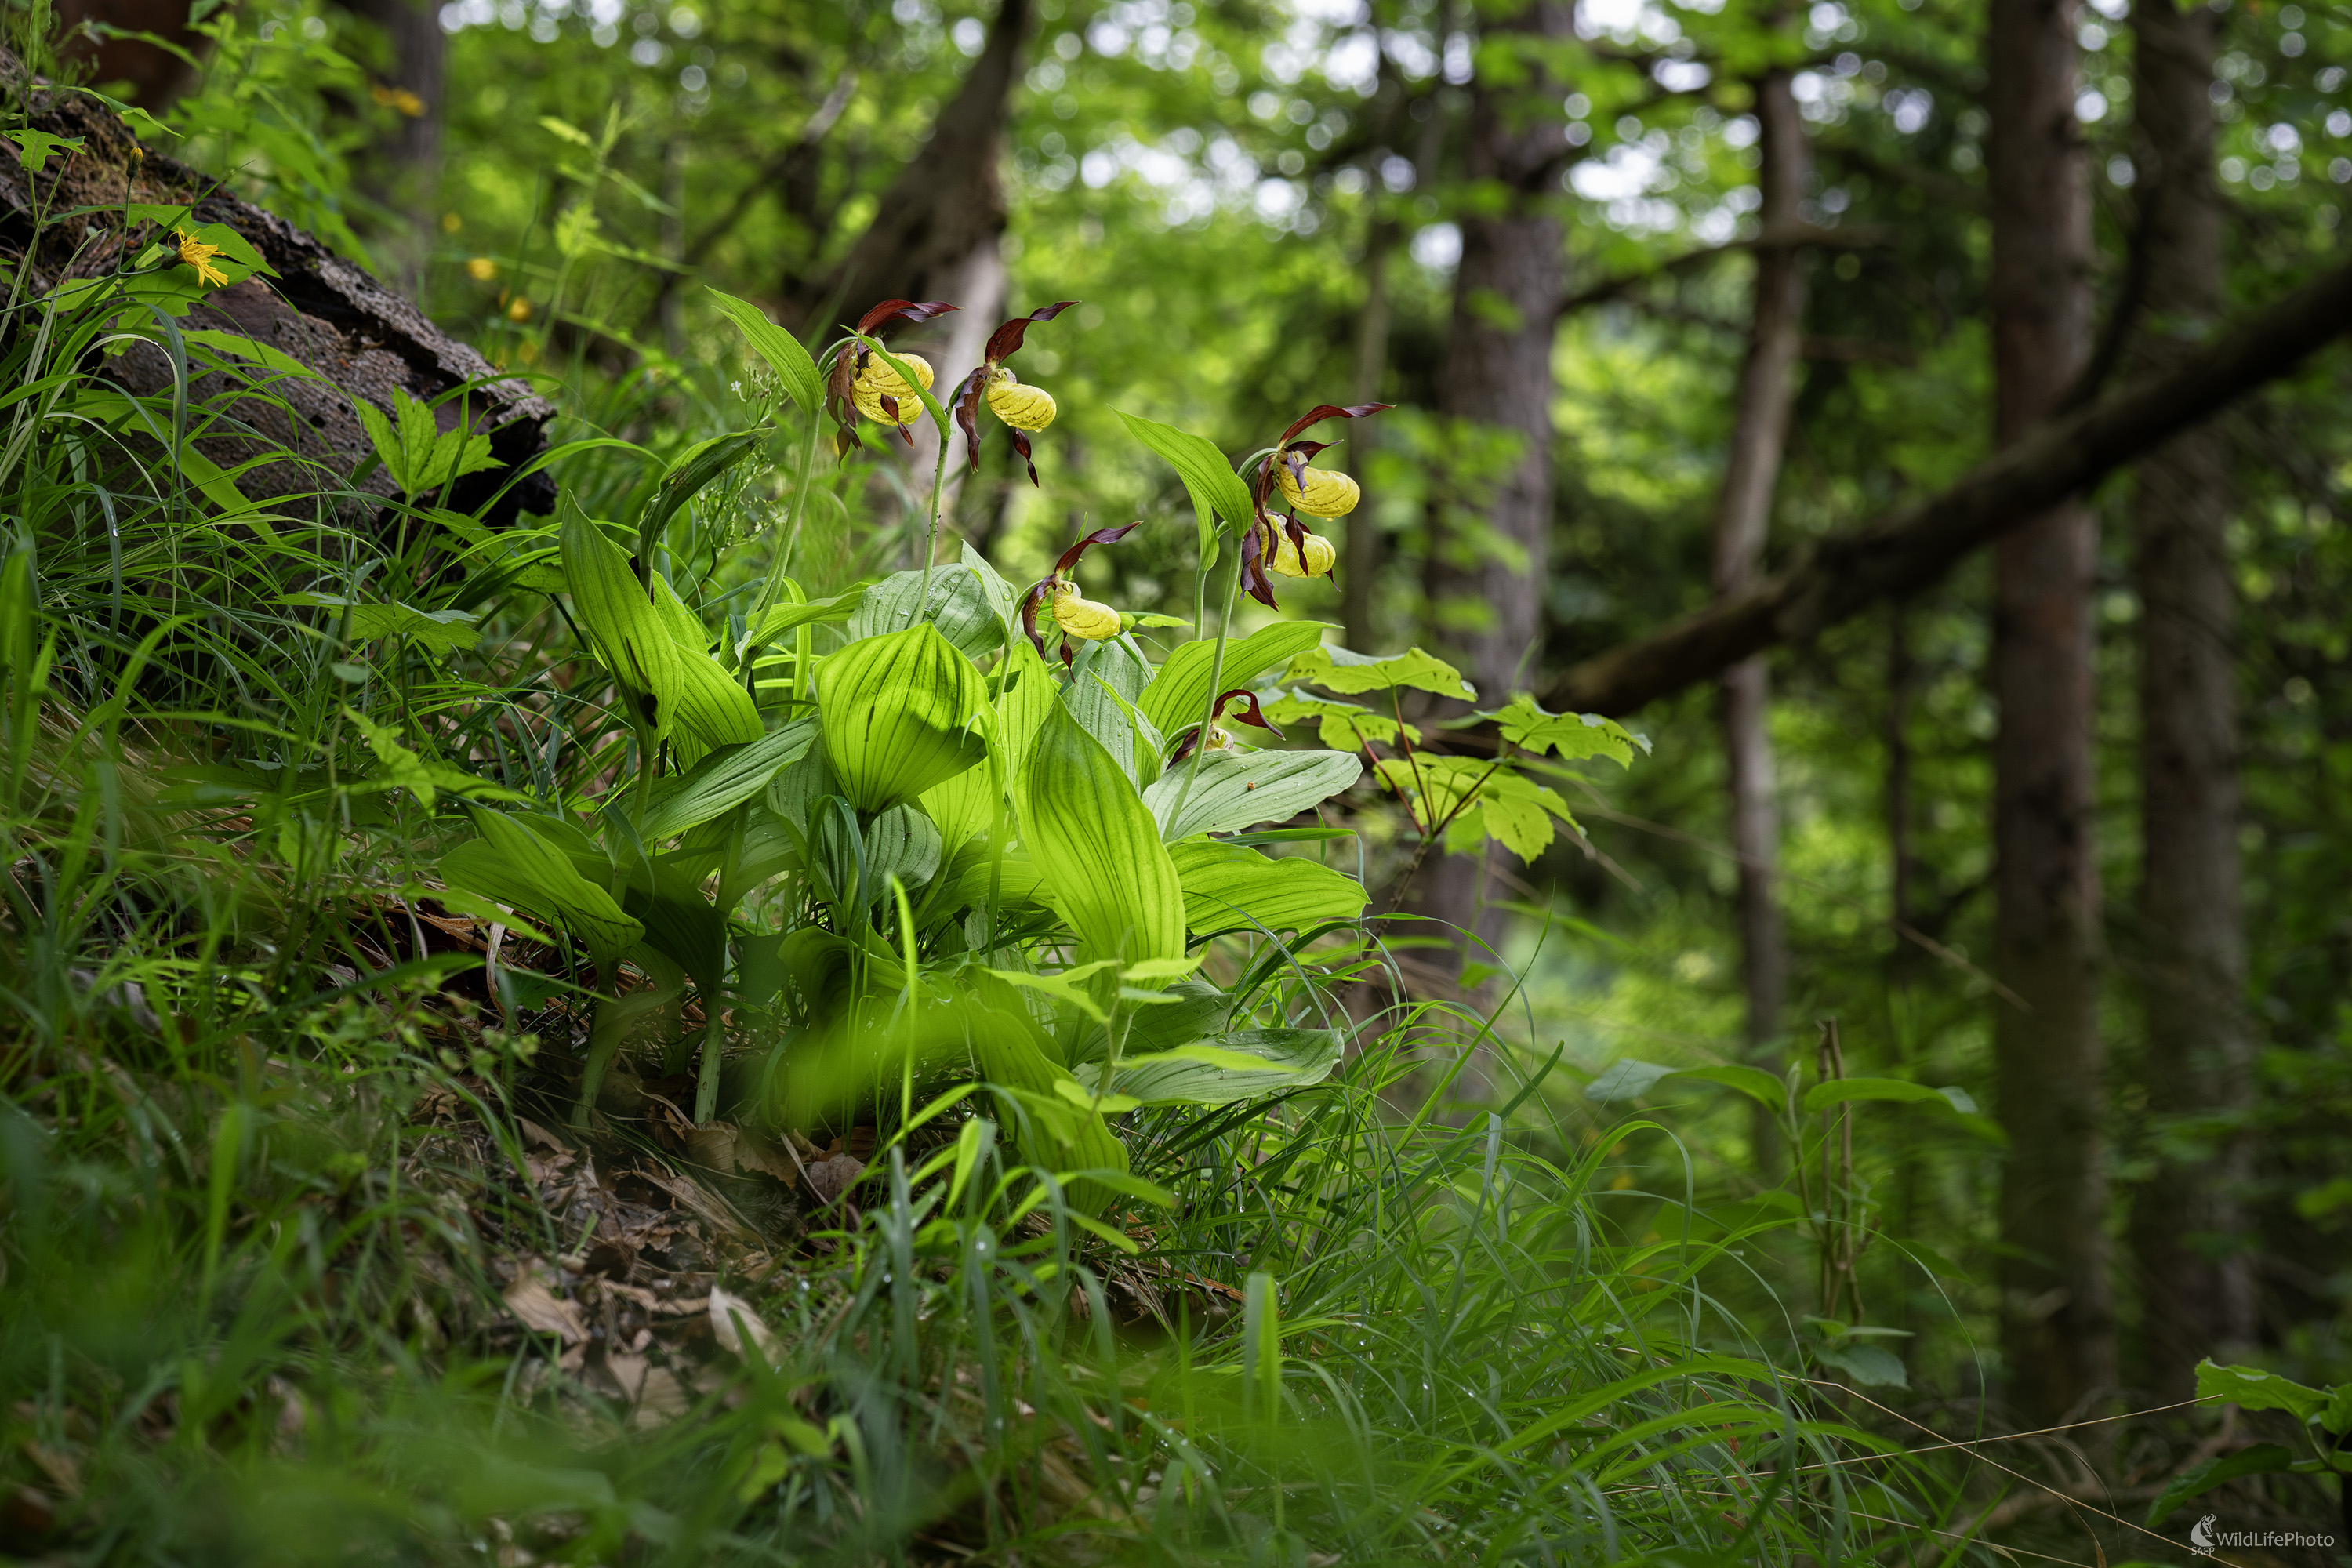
816;621;988;813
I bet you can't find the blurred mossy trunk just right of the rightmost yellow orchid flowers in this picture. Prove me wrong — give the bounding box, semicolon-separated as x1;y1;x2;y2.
1411;0;1573;1011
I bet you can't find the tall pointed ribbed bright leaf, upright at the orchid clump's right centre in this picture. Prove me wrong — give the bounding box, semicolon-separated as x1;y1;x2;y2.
1023;703;1185;964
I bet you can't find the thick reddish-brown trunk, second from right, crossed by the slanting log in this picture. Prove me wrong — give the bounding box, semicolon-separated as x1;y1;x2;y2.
1985;0;2114;1427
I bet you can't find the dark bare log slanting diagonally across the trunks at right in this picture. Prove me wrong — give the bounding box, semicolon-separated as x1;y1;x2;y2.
1543;263;2352;715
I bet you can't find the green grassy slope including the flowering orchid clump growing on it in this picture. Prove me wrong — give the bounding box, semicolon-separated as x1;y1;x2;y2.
0;135;1947;1563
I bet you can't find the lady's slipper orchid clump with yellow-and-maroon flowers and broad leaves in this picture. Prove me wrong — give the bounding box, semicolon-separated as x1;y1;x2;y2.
414;278;1630;1203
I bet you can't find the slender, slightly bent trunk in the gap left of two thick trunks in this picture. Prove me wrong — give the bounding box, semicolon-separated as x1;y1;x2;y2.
1715;68;1813;1159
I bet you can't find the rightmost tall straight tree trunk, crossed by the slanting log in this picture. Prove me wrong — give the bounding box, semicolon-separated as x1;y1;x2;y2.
2131;0;2256;1401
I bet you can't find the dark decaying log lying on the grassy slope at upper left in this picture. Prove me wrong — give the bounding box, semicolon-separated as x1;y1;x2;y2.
0;49;555;522
